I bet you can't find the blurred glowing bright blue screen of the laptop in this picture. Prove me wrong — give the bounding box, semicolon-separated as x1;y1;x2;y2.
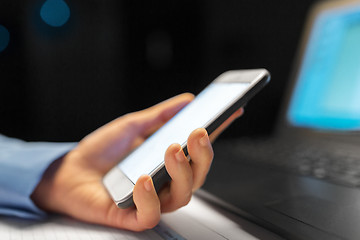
287;5;360;131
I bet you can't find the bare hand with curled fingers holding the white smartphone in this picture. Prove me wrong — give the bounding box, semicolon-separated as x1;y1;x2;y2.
31;94;242;231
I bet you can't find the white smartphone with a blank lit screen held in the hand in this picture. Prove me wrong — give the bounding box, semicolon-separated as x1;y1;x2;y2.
103;69;270;208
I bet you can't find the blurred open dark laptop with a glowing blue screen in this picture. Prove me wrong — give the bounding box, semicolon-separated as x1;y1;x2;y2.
204;0;360;240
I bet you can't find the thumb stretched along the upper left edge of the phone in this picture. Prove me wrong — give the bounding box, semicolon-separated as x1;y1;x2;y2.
77;93;194;172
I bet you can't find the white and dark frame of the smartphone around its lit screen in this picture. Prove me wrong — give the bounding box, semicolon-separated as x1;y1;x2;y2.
103;69;270;208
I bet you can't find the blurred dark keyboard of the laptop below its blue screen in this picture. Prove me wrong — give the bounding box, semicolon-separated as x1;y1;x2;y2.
224;141;360;187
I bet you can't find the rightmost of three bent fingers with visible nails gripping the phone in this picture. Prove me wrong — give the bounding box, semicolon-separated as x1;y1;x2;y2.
187;128;214;191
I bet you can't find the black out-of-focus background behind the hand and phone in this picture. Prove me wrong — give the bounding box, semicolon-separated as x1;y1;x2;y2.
0;0;314;141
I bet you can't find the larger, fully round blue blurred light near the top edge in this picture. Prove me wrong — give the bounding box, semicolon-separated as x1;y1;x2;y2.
40;0;70;27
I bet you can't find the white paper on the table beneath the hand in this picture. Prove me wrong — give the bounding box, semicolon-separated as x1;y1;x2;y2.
0;196;278;240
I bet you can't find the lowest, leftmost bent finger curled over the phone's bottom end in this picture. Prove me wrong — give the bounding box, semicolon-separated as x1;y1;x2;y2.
128;175;160;231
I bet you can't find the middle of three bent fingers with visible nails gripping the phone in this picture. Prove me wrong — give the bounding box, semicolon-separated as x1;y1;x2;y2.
159;144;193;212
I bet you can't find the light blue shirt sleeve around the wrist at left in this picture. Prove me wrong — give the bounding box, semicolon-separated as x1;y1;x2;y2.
0;134;76;219
